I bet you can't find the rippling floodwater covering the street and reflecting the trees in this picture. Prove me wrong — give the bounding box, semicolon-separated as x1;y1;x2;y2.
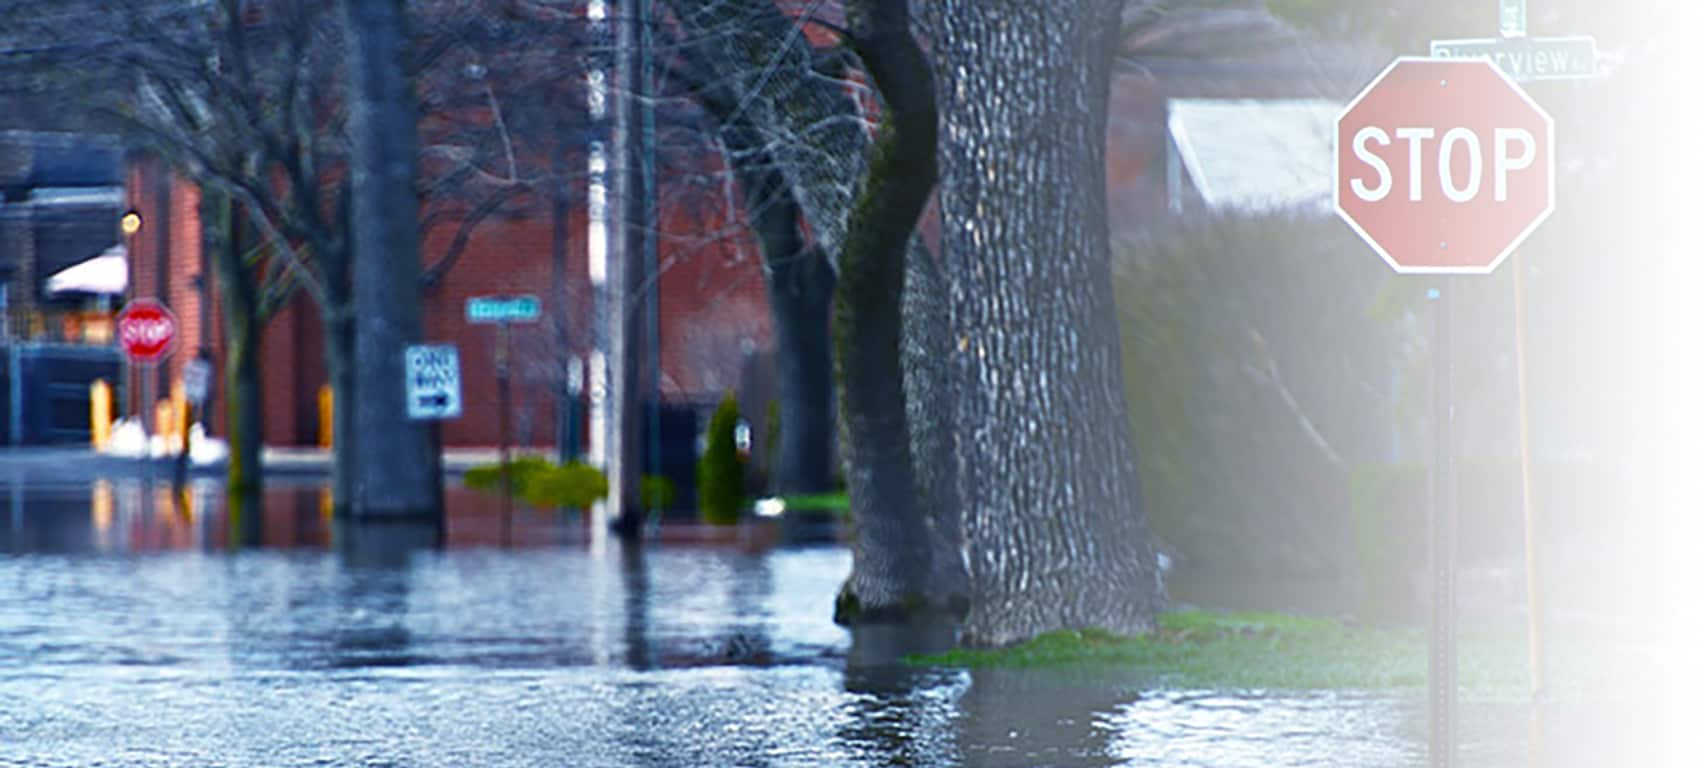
0;479;1679;768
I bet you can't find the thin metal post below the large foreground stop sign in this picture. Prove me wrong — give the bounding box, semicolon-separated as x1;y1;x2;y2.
1428;277;1459;768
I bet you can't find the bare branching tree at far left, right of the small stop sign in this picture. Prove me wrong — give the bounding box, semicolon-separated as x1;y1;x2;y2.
0;0;347;516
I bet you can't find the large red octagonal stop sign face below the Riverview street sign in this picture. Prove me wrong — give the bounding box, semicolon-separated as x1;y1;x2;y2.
1335;58;1557;274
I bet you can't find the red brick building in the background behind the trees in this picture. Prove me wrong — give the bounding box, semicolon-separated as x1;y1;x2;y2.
126;158;770;447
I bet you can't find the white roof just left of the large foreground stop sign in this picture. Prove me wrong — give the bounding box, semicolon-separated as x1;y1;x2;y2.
1168;99;1341;214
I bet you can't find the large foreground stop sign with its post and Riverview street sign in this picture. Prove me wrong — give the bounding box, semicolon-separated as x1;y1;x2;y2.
1335;0;1570;768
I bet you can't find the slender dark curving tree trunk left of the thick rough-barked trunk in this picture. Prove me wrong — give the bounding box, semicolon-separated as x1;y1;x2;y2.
833;0;949;624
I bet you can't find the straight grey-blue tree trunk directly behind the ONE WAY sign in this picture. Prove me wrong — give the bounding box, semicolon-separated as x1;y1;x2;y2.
337;0;442;518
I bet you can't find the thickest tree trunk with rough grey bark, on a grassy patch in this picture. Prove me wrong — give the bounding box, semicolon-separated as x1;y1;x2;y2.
935;0;1163;646
